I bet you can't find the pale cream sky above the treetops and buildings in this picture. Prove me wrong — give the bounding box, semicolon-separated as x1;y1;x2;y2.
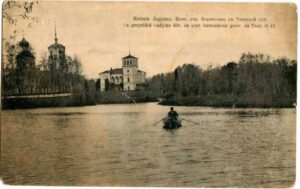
3;1;297;78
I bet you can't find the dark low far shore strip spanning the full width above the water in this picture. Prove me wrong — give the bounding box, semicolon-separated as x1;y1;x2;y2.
2;91;296;109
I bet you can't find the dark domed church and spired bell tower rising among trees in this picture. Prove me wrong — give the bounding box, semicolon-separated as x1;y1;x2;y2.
2;24;71;96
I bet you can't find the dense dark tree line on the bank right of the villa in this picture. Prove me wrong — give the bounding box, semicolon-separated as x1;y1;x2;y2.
148;53;297;107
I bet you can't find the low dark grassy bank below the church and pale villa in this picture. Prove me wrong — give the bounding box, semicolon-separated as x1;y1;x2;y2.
2;91;158;109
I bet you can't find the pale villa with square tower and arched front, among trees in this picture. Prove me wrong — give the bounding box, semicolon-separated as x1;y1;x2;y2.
99;53;146;91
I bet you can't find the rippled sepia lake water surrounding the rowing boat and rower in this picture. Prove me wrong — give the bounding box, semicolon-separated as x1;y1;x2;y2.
1;103;296;187
